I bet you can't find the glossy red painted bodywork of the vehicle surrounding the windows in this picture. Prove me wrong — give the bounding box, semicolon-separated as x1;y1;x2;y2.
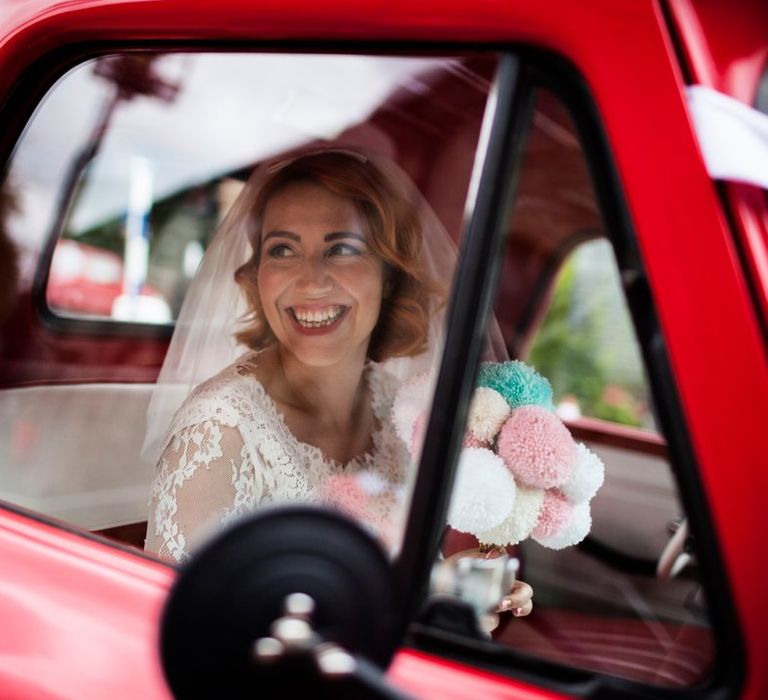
0;0;768;700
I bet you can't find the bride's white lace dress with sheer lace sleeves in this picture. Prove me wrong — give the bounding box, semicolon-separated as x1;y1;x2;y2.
145;355;412;561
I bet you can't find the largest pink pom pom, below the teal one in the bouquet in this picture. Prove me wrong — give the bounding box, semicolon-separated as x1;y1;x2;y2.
498;406;576;489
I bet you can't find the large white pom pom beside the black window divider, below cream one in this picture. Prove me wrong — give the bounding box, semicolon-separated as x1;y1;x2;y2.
448;447;517;534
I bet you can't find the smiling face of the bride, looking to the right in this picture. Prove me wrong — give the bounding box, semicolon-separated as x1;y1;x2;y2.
258;182;384;367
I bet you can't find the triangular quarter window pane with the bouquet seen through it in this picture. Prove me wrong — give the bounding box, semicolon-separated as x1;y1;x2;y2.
443;89;714;687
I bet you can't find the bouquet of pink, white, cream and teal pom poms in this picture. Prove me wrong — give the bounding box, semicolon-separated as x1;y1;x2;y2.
393;361;604;549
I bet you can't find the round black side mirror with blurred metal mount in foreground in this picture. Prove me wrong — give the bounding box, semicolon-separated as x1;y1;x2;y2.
161;506;412;700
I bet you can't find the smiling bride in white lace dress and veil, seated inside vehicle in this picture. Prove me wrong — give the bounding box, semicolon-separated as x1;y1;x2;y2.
145;149;530;614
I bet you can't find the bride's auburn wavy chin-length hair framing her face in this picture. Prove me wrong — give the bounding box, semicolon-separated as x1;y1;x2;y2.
235;151;440;362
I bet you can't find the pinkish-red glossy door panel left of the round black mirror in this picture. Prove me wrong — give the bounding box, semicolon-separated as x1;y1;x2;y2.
0;511;175;700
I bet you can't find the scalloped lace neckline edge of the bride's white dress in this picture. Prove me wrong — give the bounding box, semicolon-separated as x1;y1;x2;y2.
233;351;385;473
